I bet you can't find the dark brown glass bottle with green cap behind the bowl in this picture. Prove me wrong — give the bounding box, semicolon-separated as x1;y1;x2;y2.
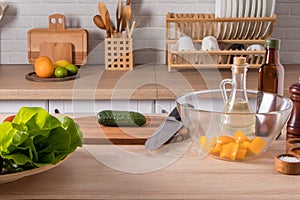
256;38;284;138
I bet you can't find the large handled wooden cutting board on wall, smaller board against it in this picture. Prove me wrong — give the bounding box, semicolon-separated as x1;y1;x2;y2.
27;14;88;65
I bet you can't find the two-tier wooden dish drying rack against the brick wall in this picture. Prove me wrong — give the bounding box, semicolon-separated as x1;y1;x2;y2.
166;13;277;71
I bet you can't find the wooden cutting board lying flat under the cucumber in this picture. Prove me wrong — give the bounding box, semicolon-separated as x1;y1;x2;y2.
75;116;189;145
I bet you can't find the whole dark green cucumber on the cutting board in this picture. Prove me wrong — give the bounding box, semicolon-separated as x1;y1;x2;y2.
97;110;146;126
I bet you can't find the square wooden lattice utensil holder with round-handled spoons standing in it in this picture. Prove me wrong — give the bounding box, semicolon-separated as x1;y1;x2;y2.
105;38;133;70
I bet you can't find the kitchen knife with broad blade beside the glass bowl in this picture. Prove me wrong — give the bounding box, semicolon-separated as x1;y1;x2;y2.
145;108;183;151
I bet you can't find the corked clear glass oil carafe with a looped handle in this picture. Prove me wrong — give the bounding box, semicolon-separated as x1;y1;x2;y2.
220;57;255;134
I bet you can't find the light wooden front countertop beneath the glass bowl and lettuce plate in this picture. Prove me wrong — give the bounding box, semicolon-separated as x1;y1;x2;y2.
0;115;300;200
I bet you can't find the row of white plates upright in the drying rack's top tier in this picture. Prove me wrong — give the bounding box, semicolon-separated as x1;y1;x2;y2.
215;0;275;40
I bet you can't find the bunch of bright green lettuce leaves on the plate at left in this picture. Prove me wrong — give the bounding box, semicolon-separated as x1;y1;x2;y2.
0;107;82;173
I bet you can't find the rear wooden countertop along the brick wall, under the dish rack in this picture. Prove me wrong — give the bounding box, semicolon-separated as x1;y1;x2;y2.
0;64;300;100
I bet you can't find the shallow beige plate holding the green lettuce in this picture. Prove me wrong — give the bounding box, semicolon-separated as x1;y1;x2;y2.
0;154;72;184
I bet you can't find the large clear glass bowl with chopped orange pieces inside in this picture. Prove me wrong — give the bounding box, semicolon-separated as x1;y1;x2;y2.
176;90;293;161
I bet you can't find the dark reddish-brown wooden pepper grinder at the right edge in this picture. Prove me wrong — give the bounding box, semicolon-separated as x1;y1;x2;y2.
286;77;300;140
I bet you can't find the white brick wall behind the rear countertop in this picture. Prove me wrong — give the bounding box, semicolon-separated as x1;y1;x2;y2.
0;0;300;64
